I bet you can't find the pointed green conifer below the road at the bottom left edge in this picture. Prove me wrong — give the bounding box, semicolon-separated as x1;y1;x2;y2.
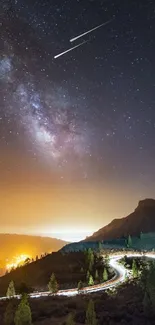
14;294;32;325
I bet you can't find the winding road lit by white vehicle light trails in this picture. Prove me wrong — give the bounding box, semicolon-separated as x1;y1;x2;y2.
0;253;155;300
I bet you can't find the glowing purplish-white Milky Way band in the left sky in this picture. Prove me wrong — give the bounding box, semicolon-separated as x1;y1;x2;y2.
0;16;91;177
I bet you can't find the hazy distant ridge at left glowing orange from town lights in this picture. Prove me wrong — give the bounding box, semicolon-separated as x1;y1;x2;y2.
0;234;67;270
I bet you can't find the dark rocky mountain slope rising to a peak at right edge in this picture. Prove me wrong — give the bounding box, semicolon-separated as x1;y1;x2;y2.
85;199;155;241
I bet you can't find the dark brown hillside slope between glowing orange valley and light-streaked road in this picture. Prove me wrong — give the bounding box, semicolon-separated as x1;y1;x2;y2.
0;252;85;296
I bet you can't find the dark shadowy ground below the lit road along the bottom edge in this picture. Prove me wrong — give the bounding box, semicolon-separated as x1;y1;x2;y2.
0;283;155;325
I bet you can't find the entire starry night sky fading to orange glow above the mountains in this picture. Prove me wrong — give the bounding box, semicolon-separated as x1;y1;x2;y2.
0;0;155;239
